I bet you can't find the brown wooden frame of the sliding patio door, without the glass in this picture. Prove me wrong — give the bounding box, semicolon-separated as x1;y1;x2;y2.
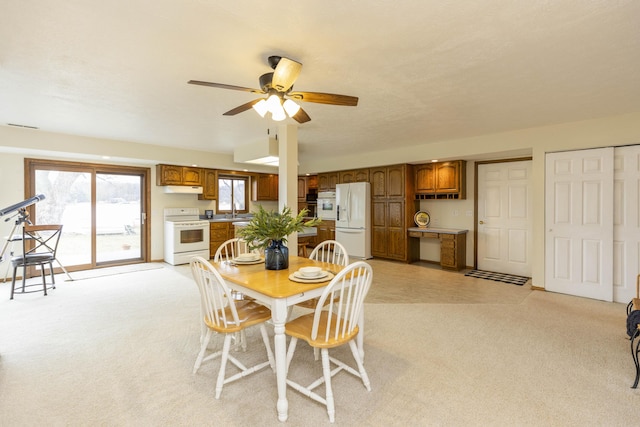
24;158;151;271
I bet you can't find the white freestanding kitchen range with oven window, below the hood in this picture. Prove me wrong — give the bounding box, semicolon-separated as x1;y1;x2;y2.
164;208;209;265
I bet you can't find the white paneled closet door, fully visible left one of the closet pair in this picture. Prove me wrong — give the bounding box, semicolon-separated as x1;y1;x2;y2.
545;147;614;301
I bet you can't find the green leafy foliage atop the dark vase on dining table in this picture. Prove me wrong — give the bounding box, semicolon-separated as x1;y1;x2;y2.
238;205;322;249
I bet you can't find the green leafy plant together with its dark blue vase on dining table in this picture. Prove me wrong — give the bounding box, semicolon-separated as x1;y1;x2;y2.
238;205;321;270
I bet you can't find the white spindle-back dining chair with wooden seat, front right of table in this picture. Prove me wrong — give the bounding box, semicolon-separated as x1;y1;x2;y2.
285;261;373;422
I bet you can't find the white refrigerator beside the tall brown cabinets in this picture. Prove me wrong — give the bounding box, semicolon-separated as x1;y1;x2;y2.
336;182;372;259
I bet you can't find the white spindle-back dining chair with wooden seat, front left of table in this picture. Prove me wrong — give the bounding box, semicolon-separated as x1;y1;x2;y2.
190;257;275;399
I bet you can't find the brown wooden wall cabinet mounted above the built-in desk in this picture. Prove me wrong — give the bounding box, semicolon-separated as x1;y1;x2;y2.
415;160;467;199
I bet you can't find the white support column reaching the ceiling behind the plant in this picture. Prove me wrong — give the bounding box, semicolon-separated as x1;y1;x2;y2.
278;125;298;251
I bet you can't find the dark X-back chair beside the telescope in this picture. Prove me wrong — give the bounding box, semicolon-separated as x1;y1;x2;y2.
10;224;62;299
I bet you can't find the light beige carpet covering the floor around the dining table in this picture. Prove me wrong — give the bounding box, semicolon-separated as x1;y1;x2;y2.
0;261;640;426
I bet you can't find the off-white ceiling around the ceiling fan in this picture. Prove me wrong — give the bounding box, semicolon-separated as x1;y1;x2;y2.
0;0;640;161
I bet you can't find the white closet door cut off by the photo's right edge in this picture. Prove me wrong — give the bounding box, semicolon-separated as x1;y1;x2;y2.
613;145;640;303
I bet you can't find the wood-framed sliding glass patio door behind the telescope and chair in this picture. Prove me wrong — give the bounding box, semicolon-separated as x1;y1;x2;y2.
25;159;149;271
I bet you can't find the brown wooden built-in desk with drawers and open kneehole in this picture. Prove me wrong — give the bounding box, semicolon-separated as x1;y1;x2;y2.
407;227;469;270
